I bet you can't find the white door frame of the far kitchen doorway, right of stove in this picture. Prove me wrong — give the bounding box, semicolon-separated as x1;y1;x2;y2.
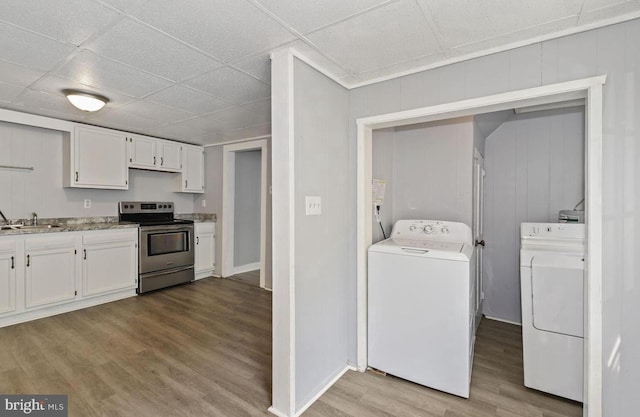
220;139;268;288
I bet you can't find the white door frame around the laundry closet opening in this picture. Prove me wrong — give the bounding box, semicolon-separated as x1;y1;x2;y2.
356;75;606;417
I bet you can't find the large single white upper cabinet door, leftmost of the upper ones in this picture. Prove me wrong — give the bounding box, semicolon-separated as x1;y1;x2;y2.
73;126;129;190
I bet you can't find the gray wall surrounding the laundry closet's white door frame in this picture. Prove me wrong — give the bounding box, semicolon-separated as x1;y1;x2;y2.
350;20;640;416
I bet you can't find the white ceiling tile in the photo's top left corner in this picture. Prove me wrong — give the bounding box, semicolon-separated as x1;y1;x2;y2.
0;0;118;45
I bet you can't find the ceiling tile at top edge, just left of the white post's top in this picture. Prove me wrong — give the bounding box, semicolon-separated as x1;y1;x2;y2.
134;0;294;62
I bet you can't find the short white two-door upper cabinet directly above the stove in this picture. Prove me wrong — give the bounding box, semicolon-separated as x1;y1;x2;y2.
127;134;182;172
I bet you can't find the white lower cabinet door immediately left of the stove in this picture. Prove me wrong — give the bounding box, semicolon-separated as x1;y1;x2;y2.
82;229;138;296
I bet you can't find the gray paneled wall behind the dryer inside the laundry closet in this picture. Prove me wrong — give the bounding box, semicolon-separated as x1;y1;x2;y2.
483;108;584;323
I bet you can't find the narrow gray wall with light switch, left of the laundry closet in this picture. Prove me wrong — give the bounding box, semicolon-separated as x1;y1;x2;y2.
293;59;355;409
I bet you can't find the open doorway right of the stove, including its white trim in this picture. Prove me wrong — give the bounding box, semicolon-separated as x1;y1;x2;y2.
221;139;268;288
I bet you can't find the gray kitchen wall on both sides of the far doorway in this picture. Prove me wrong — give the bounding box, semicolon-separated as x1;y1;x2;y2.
194;138;272;288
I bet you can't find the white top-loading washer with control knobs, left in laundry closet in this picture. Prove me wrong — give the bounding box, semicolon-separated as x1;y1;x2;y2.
368;220;475;398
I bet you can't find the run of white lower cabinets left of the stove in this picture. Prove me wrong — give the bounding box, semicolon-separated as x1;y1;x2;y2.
0;228;138;327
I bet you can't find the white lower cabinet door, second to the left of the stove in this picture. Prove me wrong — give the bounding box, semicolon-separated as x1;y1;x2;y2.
24;236;76;308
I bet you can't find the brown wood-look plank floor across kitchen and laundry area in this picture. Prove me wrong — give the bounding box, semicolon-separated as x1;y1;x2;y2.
0;278;582;417
